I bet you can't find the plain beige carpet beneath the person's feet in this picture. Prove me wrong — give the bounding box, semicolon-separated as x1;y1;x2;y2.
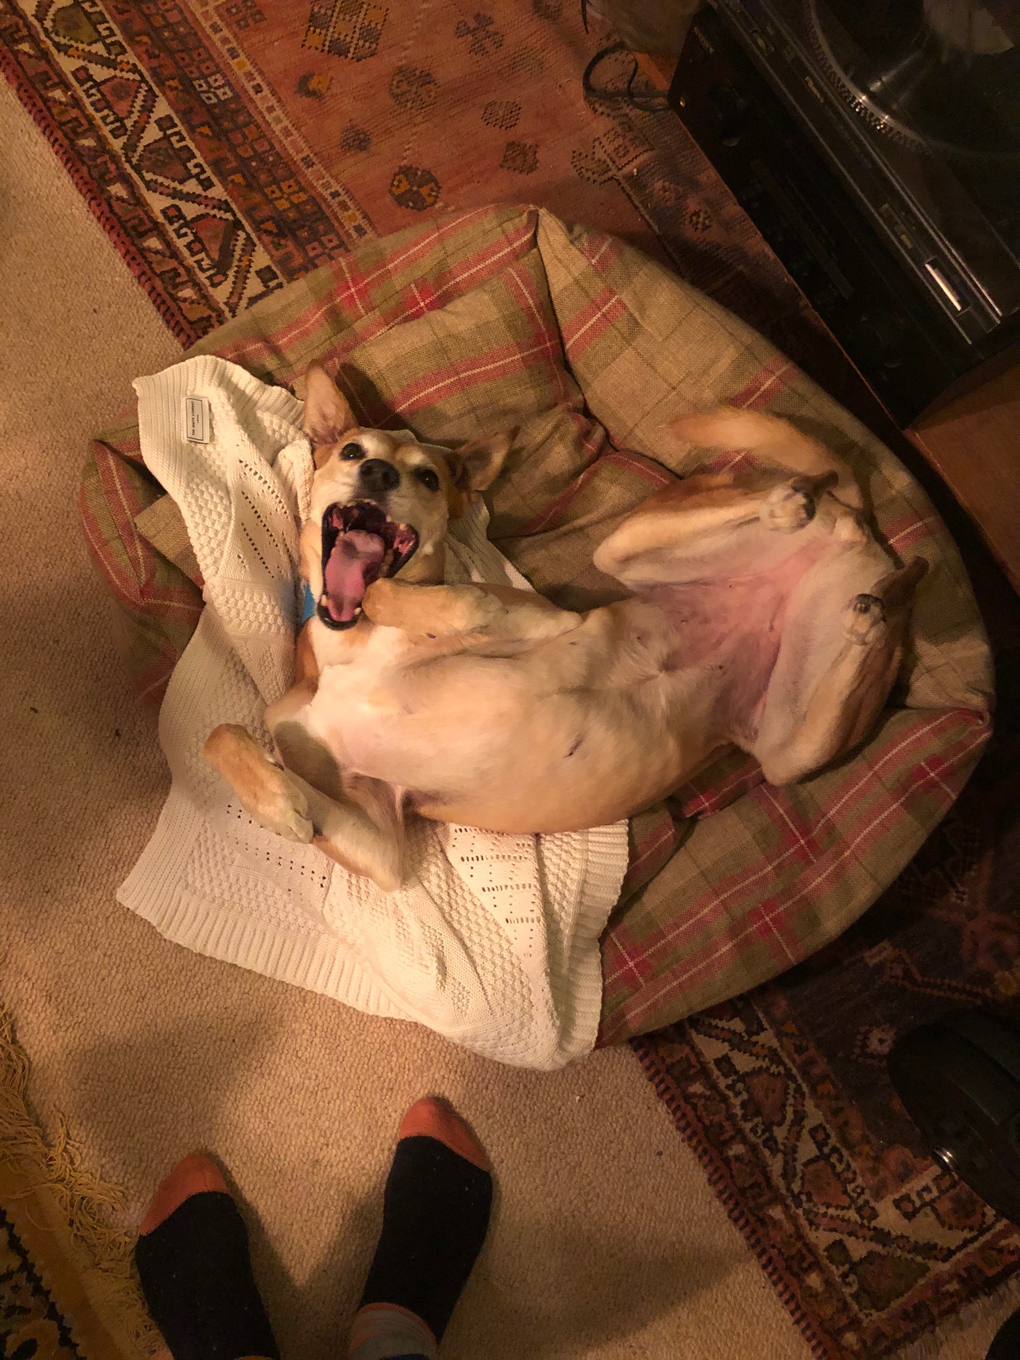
0;71;1006;1360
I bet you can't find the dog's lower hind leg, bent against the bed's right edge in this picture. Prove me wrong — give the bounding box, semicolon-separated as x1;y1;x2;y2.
738;554;928;785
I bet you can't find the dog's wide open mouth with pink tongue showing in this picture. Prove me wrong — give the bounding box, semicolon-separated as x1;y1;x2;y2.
316;500;418;628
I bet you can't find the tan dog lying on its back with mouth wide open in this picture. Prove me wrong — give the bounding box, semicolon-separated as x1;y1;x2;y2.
205;367;926;889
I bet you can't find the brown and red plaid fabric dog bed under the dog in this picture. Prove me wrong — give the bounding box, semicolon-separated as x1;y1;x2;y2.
80;207;991;1043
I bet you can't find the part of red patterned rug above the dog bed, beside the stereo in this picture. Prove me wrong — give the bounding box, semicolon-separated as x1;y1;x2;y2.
0;0;837;367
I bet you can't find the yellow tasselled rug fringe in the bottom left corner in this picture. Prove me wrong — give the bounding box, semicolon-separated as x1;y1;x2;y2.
0;1004;162;1356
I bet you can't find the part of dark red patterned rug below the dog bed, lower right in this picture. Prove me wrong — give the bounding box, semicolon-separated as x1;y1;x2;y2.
634;545;1020;1360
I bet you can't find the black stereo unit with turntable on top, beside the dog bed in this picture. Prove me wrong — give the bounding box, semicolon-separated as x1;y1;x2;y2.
669;0;1020;427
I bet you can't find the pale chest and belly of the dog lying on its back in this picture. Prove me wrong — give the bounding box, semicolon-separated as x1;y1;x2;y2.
303;622;713;832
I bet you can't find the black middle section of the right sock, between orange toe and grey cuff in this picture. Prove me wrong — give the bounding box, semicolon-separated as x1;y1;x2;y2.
360;1134;492;1341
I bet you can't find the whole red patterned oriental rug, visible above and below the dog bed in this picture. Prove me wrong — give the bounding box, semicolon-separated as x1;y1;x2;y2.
0;0;1020;1360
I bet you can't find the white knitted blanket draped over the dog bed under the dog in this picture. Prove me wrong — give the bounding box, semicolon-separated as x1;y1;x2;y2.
118;356;627;1069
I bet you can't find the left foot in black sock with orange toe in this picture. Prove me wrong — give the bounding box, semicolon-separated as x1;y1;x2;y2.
135;1153;279;1360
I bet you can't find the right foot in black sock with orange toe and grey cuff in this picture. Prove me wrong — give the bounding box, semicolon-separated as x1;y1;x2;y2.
350;1096;492;1360
